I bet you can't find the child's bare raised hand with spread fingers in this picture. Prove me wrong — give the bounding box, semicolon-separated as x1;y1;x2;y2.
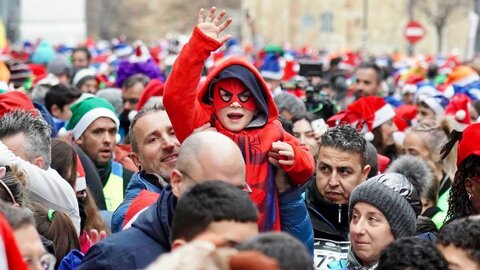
197;7;232;44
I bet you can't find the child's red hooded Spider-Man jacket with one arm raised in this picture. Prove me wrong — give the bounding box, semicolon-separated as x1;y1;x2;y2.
163;27;314;231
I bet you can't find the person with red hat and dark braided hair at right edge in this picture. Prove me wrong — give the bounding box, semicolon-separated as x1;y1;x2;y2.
443;123;480;223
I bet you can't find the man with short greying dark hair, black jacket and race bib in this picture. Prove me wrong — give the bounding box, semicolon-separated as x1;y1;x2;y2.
305;126;370;266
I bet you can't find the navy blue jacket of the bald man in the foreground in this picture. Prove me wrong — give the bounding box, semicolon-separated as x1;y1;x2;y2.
78;187;176;270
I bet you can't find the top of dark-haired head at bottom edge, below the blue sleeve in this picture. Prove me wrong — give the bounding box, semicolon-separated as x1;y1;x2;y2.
237;232;313;270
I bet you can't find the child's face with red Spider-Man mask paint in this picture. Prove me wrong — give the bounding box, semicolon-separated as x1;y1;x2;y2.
213;79;257;132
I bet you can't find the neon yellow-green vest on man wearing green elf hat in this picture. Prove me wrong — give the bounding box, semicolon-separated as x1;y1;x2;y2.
103;161;124;212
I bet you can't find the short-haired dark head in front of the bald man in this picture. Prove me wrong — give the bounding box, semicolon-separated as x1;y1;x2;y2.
171;181;258;248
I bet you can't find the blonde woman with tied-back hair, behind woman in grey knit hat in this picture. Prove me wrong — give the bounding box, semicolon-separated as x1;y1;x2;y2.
403;118;456;229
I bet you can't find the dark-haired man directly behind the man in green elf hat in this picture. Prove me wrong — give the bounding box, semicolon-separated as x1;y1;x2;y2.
45;84;82;131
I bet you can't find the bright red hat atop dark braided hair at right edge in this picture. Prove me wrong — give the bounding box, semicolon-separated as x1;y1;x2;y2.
457;123;480;166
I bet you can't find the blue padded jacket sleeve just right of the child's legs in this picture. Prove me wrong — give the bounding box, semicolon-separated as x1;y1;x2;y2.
278;187;313;255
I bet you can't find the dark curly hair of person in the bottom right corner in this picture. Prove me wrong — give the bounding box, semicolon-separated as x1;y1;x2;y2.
437;217;480;265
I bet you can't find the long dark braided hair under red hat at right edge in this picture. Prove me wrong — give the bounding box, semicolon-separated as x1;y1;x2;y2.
447;155;480;220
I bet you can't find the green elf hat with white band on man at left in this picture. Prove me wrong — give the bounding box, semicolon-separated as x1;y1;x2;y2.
66;96;120;140
